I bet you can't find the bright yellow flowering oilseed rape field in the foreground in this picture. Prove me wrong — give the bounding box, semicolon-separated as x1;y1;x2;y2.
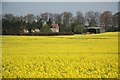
1;32;118;78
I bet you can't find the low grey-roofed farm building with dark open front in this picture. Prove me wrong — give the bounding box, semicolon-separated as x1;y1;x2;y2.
83;27;105;34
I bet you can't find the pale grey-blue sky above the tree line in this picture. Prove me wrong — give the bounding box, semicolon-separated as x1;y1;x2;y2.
2;1;118;16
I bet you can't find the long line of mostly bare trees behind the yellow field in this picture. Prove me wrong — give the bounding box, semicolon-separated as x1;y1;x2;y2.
2;11;120;34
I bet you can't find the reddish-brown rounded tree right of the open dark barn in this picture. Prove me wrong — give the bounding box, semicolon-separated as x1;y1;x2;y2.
100;11;112;31
